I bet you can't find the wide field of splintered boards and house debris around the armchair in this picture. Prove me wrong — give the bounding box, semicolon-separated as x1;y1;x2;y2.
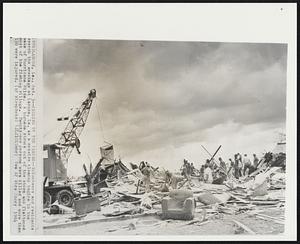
44;146;285;234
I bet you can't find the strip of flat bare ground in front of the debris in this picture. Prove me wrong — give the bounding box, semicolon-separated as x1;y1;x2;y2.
44;208;284;235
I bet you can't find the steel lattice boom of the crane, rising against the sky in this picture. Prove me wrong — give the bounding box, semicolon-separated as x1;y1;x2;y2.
58;89;96;164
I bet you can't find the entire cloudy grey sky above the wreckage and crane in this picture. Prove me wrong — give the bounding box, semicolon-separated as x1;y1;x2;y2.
43;40;287;175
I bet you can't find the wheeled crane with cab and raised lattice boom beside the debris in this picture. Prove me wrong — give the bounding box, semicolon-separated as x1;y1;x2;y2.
43;89;96;208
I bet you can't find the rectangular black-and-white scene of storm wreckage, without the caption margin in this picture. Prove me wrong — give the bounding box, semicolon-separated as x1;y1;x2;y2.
43;39;287;235
